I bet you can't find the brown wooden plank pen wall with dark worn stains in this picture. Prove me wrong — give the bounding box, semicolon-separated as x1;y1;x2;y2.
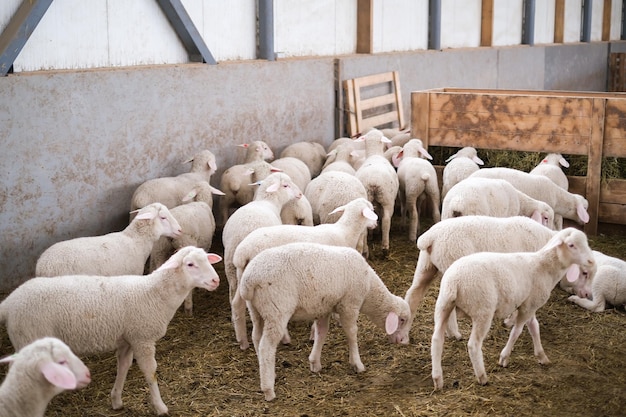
411;88;626;235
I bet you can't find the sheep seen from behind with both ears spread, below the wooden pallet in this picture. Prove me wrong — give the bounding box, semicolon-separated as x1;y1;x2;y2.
356;129;400;256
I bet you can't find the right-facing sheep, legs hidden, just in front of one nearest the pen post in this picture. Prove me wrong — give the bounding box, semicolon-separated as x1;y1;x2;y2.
441;177;554;228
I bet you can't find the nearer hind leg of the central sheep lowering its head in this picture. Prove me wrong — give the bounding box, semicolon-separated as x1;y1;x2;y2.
257;319;288;401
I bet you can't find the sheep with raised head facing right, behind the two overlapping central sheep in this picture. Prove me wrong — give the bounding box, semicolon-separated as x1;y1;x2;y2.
222;172;302;324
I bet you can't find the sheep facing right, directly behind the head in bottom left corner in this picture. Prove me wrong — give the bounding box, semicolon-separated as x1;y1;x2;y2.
0;247;222;415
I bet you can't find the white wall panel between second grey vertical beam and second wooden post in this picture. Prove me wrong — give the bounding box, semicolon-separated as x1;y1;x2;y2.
441;0;482;49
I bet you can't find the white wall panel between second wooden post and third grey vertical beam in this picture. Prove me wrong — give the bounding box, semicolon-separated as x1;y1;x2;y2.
491;0;524;46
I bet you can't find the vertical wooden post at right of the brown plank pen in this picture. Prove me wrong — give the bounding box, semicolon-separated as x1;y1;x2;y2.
585;98;606;235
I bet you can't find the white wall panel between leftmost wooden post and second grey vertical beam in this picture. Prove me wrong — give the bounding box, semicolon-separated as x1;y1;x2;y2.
372;0;428;53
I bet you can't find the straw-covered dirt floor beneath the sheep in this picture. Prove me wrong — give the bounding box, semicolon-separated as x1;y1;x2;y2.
0;217;626;417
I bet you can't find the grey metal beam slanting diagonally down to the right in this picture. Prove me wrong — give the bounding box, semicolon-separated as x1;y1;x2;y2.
157;0;217;65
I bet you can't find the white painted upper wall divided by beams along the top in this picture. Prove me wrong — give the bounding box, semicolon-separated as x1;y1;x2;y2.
0;0;622;72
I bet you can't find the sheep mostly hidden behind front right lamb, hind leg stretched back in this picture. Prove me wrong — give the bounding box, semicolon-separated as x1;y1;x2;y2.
391;216;555;344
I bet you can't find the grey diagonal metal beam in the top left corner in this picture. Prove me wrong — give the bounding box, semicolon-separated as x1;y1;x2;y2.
0;0;52;77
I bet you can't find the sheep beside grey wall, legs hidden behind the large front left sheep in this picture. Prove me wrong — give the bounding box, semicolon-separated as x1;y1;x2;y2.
35;203;182;277
